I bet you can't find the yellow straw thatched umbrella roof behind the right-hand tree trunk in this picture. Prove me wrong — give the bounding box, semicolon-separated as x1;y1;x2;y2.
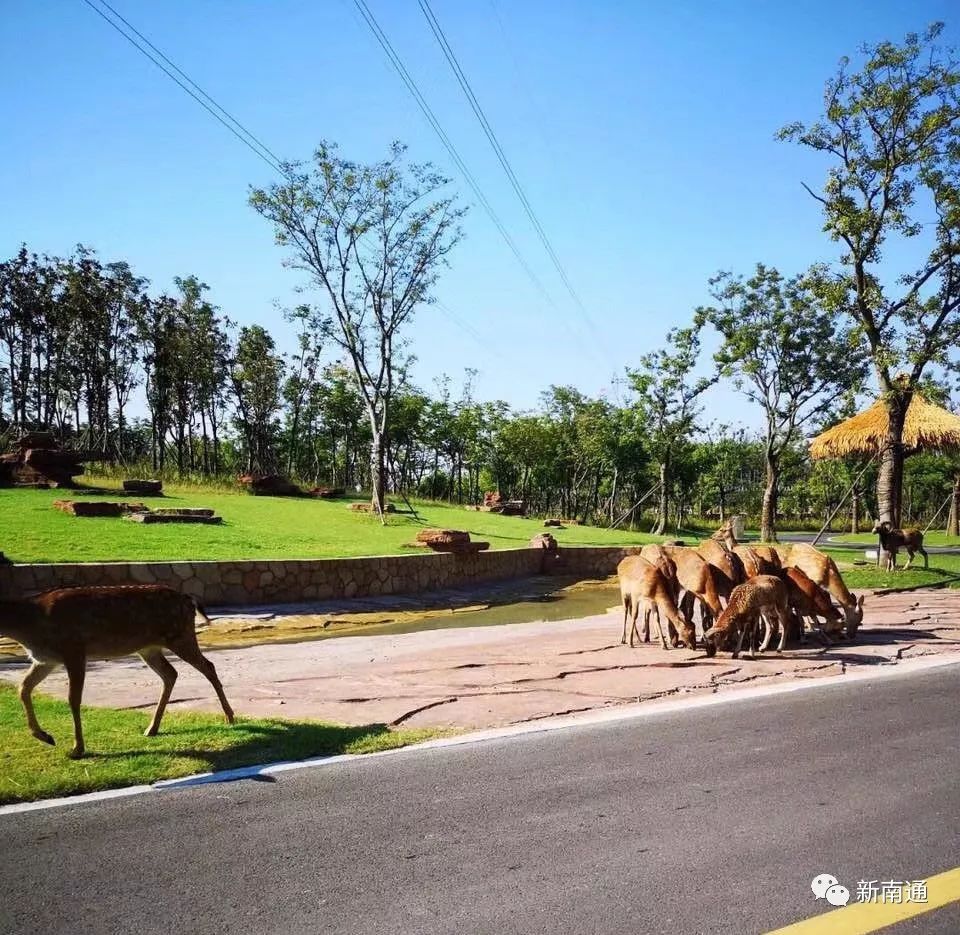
810;393;960;459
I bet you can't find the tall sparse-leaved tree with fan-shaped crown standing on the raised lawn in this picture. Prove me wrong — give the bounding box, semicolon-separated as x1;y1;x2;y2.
250;143;465;516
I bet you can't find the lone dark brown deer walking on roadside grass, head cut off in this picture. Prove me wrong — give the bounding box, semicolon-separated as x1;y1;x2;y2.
0;584;234;760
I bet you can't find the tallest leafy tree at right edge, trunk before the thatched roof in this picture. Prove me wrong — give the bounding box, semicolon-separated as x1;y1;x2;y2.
779;23;960;526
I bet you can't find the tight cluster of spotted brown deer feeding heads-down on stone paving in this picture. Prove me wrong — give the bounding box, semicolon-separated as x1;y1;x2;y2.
617;524;868;658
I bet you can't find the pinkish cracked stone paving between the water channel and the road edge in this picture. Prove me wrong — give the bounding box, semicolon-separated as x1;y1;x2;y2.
0;590;960;729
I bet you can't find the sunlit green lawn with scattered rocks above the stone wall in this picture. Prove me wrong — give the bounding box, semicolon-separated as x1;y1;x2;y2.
0;485;672;562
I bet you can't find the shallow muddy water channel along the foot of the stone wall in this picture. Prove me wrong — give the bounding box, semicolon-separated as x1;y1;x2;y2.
0;578;620;660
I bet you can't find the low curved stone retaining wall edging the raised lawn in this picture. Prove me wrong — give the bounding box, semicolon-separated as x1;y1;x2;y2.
0;547;639;604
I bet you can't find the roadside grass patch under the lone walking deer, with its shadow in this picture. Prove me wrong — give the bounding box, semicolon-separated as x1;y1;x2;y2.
0;682;445;804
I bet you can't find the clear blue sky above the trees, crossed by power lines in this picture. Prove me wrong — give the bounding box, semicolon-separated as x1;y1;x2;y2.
0;0;958;424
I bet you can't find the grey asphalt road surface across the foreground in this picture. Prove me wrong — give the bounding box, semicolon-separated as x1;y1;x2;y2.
0;666;960;935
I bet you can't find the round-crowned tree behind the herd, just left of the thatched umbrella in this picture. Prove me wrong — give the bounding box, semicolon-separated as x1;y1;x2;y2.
697;263;865;542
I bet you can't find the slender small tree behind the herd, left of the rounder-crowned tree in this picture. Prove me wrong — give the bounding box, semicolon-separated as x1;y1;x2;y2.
627;325;717;535
